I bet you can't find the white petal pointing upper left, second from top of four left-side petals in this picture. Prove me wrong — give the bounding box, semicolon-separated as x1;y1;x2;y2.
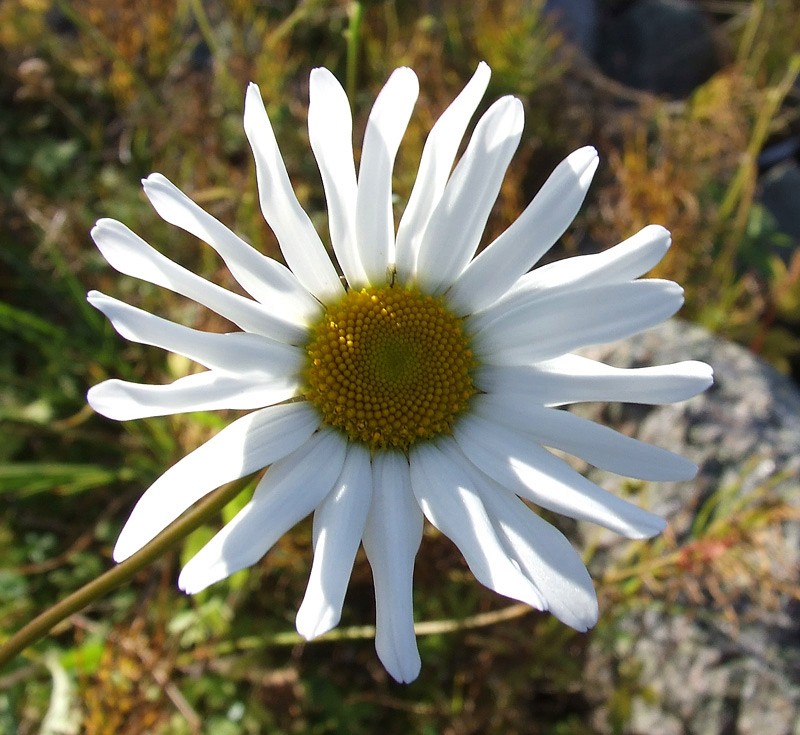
91;219;307;344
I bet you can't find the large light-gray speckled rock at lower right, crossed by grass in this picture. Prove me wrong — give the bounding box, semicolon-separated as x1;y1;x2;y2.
581;320;800;735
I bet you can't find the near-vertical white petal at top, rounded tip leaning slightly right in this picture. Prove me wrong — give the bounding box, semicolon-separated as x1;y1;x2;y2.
356;67;419;285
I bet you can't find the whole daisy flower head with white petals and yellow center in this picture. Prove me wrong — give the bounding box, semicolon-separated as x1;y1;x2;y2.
88;63;711;682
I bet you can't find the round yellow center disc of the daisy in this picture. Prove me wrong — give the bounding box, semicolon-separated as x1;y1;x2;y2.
305;286;475;450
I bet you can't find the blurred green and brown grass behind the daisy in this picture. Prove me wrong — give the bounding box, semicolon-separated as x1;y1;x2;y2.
0;0;800;735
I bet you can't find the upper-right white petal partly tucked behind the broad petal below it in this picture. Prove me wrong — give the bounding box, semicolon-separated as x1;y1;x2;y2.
503;225;672;296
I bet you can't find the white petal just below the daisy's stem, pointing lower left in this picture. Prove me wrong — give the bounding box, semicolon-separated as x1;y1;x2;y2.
178;429;347;594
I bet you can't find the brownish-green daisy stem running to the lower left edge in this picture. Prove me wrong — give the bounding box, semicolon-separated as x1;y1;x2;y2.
0;477;250;667
